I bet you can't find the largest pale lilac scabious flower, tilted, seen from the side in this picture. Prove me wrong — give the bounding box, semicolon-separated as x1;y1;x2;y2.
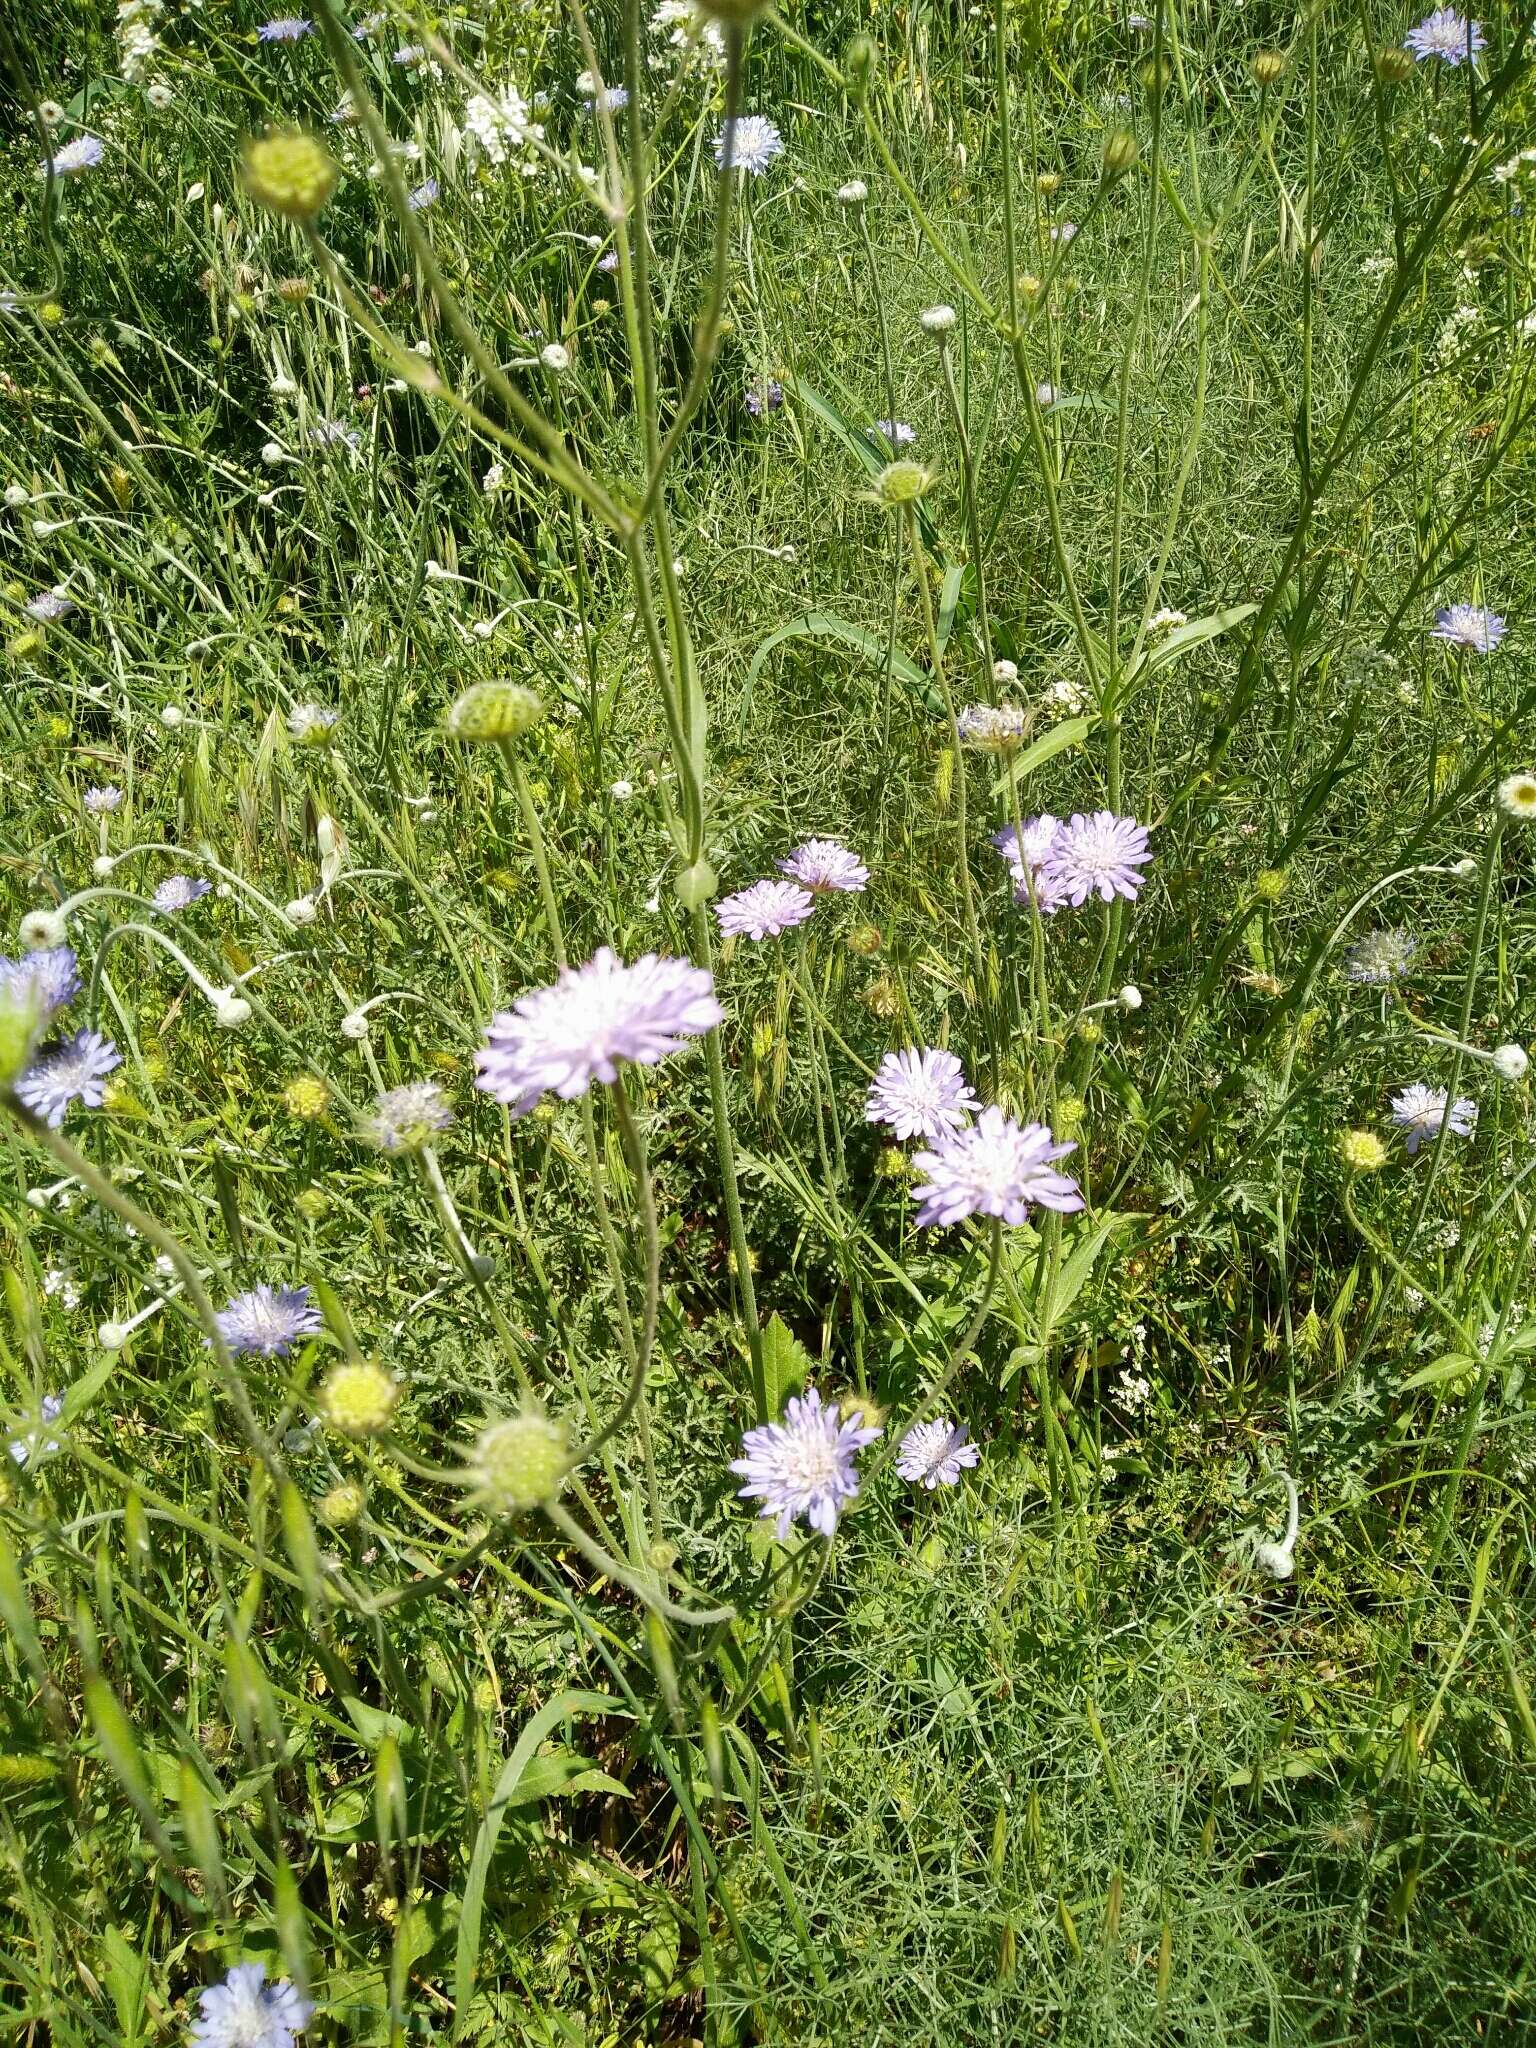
475;946;725;1116
